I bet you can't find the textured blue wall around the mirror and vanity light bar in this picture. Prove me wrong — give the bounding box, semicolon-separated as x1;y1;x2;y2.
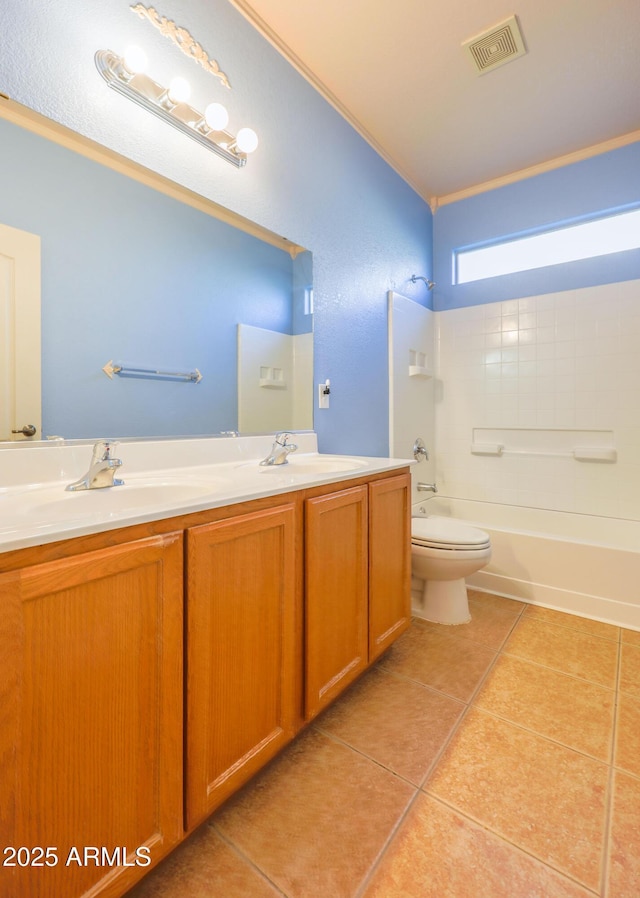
0;0;433;455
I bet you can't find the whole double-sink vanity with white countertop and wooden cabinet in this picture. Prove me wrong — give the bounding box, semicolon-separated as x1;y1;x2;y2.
0;433;410;898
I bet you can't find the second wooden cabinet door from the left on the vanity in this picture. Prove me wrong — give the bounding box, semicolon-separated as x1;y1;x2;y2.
186;505;300;829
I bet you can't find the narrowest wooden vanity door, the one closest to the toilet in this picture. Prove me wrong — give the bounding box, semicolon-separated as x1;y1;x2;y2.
369;474;411;663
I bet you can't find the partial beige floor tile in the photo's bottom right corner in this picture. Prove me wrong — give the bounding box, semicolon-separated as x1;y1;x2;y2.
605;771;640;898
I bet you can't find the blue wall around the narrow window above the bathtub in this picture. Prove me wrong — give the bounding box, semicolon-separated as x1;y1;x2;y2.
434;143;640;310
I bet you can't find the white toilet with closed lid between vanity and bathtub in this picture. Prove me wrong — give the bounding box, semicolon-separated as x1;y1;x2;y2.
411;515;491;624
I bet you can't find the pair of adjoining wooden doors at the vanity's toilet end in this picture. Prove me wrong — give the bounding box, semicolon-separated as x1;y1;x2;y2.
305;474;411;720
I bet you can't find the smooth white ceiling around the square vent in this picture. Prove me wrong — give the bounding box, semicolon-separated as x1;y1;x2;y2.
231;0;640;204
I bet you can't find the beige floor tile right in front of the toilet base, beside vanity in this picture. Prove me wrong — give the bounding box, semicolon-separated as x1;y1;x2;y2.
380;621;496;702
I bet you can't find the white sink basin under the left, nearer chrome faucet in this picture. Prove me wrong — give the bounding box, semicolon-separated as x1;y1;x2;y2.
10;477;228;524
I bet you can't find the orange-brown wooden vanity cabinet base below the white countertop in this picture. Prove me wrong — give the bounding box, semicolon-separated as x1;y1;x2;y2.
0;470;410;898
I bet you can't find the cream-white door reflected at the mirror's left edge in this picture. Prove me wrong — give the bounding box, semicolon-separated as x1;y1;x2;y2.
0;224;42;440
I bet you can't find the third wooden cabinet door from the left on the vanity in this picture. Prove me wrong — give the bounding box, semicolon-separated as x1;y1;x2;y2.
305;486;368;719
